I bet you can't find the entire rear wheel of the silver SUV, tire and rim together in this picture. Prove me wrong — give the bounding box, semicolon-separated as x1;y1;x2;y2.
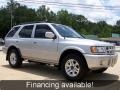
8;49;22;68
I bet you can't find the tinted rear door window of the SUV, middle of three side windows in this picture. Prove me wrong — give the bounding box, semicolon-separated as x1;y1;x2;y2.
19;25;34;38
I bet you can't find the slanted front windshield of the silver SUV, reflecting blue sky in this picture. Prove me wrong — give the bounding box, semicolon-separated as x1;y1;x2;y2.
52;24;84;38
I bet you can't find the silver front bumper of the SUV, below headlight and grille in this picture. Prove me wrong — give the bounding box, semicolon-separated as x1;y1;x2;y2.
84;54;118;70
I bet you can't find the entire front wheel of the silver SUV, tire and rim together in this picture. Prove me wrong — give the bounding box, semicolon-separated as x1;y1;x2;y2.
61;54;87;81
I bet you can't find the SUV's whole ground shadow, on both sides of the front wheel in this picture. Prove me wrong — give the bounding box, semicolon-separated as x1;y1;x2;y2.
2;63;119;87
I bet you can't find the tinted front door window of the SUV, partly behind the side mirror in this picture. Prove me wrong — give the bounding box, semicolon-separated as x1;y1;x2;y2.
34;25;51;38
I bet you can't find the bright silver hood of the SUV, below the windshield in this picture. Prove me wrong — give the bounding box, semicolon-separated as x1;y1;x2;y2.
66;38;114;46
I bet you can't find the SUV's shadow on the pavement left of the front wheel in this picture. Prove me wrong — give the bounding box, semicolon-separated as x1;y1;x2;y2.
2;63;64;80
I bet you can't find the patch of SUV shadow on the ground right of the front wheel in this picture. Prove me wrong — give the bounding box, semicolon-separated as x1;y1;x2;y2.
84;72;119;87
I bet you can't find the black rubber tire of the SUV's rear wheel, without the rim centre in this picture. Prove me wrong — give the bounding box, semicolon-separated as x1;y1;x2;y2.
8;49;22;68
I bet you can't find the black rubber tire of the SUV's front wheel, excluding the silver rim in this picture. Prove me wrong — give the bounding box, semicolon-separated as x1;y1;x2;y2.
61;54;87;81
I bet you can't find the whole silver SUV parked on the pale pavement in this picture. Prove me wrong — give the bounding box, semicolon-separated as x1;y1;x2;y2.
3;23;118;80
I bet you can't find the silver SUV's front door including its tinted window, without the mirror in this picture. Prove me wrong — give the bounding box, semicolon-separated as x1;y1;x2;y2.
33;24;58;62
